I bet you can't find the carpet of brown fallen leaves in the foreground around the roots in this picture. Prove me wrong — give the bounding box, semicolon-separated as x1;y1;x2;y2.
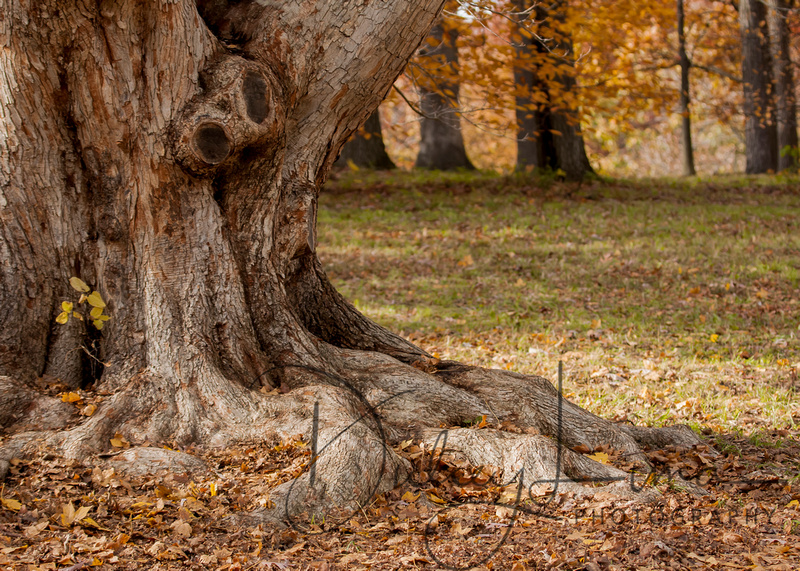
0;428;800;571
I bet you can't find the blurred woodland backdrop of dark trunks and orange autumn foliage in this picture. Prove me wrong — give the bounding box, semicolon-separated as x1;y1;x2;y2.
340;0;800;179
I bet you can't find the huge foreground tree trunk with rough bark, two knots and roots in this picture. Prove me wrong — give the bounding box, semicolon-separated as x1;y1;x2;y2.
0;0;697;519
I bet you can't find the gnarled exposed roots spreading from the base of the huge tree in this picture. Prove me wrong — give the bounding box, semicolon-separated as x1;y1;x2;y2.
0;347;700;523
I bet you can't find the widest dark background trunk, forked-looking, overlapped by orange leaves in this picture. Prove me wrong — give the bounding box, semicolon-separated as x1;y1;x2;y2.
514;0;593;181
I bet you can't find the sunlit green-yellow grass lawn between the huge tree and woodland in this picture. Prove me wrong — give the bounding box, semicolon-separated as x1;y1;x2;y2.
319;171;800;431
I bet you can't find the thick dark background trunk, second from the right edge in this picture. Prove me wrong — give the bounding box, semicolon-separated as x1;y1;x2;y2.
739;0;778;174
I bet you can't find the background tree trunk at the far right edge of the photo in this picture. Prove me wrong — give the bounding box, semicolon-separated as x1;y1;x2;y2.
768;0;798;171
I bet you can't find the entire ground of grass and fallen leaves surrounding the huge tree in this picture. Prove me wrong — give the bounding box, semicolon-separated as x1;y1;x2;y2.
0;171;800;571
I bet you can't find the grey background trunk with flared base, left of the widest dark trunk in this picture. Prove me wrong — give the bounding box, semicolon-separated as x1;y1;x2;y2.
414;20;475;170
